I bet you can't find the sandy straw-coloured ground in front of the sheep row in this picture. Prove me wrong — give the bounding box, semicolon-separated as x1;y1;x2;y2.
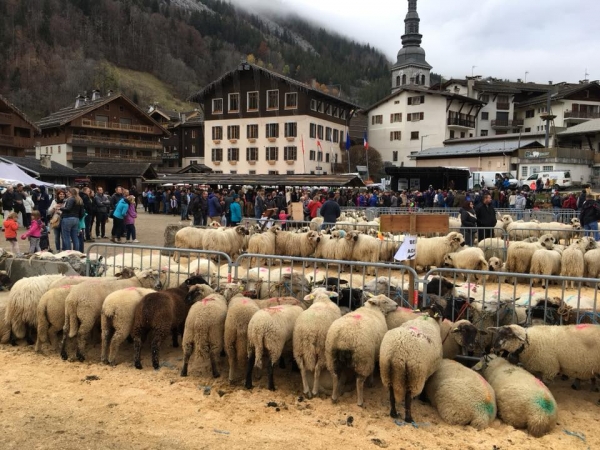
0;212;600;450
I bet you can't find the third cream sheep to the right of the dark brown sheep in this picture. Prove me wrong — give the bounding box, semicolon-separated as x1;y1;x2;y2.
245;305;304;391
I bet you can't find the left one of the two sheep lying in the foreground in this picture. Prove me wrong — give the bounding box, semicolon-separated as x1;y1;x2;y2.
425;359;497;430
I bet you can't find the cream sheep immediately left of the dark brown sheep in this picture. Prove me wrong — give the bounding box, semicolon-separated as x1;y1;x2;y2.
100;287;156;366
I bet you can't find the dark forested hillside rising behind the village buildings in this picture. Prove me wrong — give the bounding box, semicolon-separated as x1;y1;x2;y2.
0;0;404;119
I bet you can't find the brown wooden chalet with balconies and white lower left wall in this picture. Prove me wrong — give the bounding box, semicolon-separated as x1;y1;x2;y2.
36;91;169;169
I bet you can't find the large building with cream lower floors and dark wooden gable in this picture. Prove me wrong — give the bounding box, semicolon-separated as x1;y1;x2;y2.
185;62;358;175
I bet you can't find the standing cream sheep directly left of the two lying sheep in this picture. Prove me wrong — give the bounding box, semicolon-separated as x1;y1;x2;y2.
379;316;443;423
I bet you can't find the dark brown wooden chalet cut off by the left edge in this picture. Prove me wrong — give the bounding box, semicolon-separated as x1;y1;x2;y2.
0;95;40;156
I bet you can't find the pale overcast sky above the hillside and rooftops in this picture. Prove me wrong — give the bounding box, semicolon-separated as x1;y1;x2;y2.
234;0;600;83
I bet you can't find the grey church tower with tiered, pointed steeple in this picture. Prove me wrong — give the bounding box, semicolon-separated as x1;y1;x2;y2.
392;0;431;92
